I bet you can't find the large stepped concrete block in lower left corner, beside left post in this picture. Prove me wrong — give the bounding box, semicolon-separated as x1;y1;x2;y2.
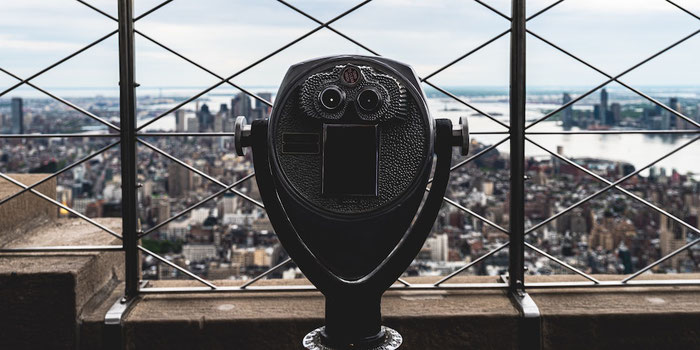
0;219;124;349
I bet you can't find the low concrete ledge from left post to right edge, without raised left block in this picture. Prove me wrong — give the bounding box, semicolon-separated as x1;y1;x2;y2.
90;275;700;350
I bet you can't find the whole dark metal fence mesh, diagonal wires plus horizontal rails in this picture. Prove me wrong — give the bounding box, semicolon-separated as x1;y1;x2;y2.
0;0;700;295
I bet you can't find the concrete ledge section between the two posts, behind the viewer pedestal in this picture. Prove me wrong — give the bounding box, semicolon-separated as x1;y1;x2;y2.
120;277;517;350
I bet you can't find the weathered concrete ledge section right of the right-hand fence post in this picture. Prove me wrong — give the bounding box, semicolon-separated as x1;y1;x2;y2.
529;274;700;350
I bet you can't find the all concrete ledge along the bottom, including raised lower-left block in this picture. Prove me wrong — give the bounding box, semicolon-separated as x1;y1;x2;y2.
0;219;700;350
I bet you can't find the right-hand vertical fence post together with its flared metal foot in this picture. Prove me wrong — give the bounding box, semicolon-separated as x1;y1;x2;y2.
508;0;542;349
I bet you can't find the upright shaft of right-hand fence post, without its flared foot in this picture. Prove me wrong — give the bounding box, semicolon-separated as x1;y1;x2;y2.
508;0;525;291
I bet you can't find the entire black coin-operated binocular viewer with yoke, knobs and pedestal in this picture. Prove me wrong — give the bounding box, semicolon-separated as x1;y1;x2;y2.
235;56;469;349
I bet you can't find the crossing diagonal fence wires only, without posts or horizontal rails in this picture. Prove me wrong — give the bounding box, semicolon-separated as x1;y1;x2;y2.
0;0;700;289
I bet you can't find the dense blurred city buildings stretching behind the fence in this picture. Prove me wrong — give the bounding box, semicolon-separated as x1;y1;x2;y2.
0;89;700;279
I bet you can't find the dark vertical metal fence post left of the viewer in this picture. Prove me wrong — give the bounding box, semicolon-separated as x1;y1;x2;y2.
117;0;141;300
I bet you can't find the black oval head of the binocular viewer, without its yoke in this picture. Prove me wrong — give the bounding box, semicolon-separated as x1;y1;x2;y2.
267;56;434;280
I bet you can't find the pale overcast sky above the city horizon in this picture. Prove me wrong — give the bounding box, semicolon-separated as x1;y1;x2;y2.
0;0;700;94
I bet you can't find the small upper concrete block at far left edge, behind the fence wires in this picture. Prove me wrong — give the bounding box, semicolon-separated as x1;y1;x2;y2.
0;174;58;247
